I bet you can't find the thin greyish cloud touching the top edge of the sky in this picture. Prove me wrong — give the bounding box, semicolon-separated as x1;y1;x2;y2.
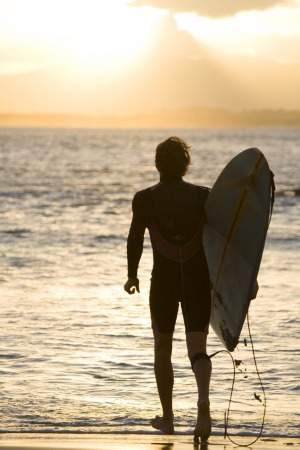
130;0;292;18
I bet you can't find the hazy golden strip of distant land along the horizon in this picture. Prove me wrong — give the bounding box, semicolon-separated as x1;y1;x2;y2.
0;107;300;128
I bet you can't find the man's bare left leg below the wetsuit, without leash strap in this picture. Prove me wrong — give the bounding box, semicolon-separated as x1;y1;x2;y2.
151;327;174;434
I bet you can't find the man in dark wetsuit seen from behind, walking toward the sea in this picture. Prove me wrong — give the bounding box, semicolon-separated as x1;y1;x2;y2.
124;137;211;441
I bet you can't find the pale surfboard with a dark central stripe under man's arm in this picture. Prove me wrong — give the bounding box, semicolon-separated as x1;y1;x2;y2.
203;148;275;351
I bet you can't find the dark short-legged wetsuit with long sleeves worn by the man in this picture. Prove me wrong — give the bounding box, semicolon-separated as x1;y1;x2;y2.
127;178;211;333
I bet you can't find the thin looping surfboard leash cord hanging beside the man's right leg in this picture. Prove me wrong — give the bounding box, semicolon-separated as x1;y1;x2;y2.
210;314;267;447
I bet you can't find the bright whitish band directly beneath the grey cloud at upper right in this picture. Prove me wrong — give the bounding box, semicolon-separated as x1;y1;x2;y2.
176;7;300;63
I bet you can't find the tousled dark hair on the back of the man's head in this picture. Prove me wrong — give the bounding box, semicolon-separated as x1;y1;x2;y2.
155;136;191;178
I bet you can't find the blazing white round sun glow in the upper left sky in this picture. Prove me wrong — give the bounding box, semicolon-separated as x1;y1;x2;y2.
58;2;157;65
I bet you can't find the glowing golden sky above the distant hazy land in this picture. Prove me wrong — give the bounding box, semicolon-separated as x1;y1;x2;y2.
0;0;300;116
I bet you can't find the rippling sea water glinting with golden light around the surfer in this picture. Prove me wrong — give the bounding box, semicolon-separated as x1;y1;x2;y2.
0;128;300;436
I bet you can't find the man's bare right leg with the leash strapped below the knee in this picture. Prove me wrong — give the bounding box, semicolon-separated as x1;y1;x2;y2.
186;331;211;440
